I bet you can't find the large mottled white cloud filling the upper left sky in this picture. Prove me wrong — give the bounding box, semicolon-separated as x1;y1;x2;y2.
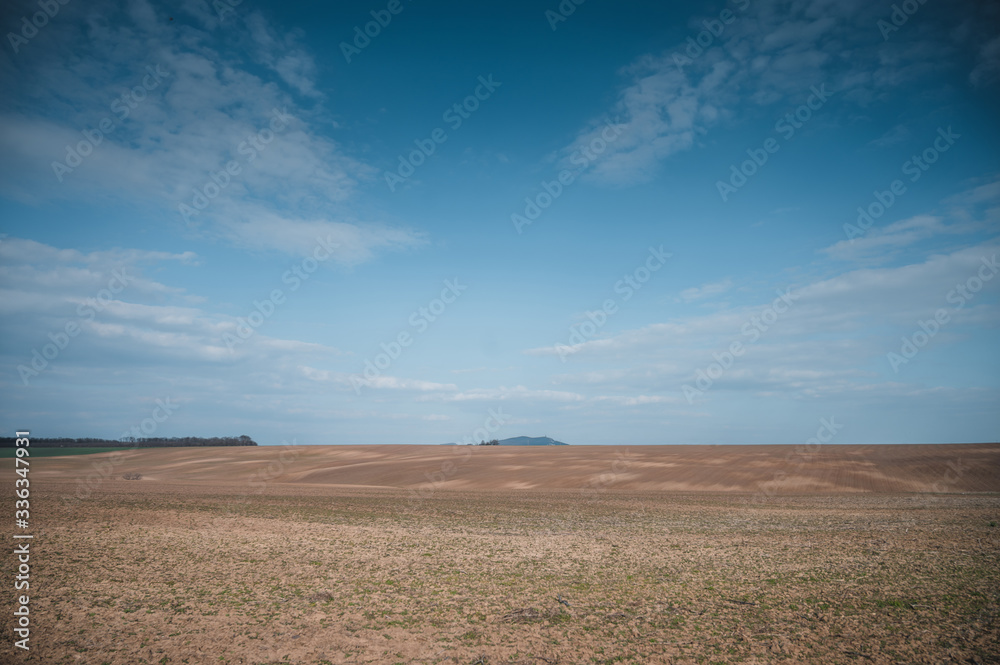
0;0;423;264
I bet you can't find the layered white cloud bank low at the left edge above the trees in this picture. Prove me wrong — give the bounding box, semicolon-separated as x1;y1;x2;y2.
0;238;362;382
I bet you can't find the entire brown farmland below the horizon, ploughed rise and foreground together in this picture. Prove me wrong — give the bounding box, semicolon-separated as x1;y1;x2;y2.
0;444;1000;665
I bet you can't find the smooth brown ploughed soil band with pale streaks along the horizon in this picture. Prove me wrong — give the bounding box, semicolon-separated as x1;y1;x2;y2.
27;444;1000;494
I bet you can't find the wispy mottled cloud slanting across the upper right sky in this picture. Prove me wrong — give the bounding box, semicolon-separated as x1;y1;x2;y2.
560;1;988;185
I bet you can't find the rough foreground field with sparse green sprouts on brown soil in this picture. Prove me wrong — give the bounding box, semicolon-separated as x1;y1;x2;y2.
0;483;1000;664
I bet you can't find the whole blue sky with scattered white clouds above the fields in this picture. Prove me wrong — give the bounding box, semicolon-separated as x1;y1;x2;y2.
0;0;1000;445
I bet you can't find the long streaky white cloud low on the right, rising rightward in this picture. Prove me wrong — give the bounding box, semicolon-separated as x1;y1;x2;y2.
526;233;1000;397
